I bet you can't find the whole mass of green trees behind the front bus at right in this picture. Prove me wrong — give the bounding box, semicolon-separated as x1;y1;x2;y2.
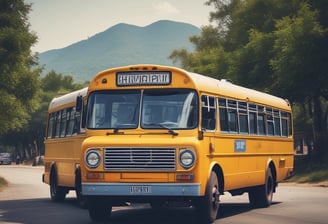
170;0;328;159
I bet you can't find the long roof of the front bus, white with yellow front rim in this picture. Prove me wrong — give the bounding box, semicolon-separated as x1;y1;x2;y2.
91;64;291;111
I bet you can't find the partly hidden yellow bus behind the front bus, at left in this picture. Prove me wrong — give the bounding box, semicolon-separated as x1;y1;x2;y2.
42;88;88;205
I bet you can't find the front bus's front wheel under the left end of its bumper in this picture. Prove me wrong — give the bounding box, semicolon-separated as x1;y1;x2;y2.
88;198;112;222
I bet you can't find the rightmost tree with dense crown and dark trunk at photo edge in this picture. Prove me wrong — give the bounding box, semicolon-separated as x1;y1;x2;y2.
271;3;328;158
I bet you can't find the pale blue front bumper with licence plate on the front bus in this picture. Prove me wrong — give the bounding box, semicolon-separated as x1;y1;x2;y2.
82;183;200;196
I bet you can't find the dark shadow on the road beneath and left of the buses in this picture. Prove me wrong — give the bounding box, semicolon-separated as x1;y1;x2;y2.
0;198;280;224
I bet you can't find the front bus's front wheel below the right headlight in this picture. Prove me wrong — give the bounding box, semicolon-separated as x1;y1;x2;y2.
195;171;220;223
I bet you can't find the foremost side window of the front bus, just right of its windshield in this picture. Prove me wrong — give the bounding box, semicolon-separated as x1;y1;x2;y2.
202;96;216;131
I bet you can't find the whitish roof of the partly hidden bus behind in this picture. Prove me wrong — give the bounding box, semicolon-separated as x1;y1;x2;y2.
48;87;88;111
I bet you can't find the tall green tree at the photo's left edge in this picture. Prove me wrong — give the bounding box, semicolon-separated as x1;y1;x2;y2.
0;0;41;135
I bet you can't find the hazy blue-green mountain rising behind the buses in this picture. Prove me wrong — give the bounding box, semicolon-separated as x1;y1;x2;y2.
39;20;201;82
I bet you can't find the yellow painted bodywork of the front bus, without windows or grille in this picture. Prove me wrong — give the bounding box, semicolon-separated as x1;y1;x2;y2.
81;65;294;195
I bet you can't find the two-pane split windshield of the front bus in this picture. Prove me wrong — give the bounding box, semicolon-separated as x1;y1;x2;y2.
87;89;198;130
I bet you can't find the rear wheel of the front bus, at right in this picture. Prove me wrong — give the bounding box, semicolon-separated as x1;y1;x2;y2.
248;168;274;208
